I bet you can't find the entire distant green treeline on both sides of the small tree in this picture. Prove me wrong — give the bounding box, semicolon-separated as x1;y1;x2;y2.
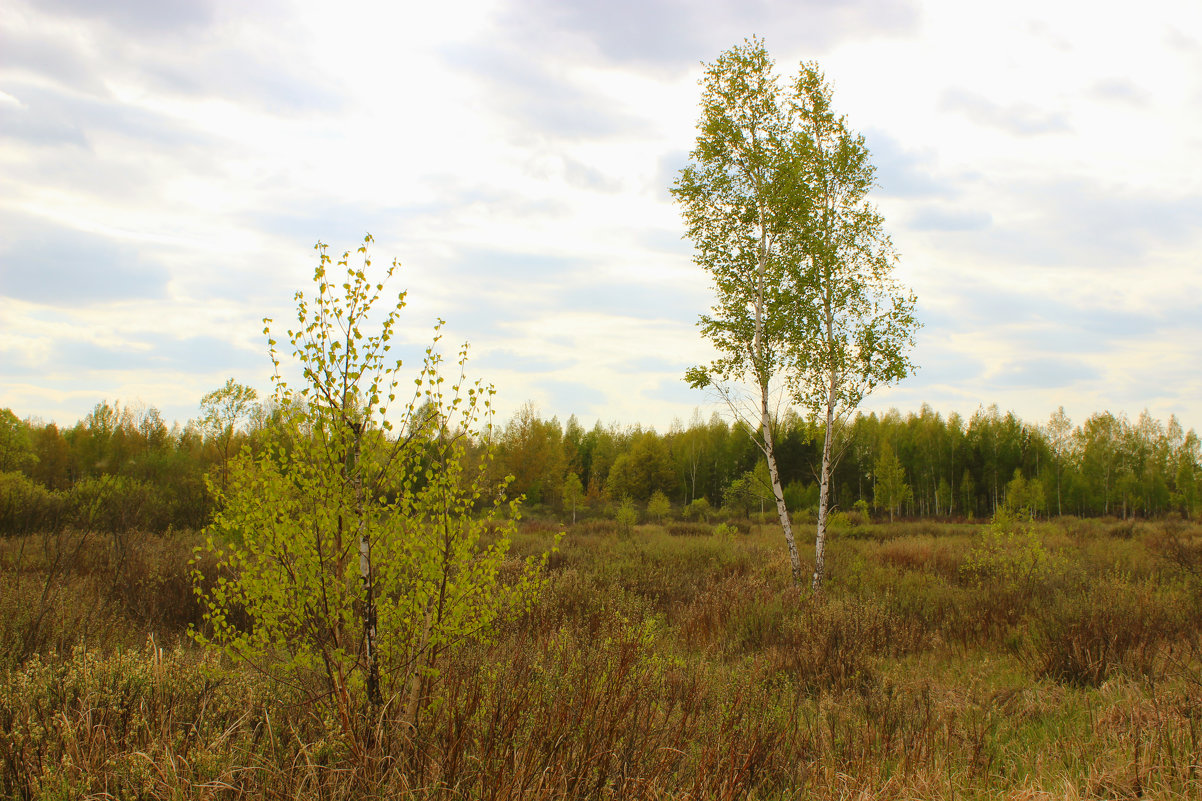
0;385;1202;534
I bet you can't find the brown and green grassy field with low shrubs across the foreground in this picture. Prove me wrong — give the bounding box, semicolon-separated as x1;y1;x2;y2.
0;518;1202;799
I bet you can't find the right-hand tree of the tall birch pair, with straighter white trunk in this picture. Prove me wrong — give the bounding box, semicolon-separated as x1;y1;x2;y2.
785;63;918;591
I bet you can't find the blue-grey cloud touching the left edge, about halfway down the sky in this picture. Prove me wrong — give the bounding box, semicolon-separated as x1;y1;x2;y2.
0;215;168;305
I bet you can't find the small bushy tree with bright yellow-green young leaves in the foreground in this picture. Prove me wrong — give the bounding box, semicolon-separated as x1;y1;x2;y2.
194;237;550;742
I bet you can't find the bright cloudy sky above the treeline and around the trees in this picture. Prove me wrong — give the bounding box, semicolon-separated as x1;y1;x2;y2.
0;0;1202;431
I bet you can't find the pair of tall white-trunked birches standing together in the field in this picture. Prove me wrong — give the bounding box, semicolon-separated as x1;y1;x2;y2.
672;38;917;591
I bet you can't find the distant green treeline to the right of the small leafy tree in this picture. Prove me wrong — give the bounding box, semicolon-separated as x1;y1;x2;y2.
490;404;1202;517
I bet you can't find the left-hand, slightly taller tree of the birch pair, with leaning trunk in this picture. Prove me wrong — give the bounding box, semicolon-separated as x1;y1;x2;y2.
672;40;807;583
